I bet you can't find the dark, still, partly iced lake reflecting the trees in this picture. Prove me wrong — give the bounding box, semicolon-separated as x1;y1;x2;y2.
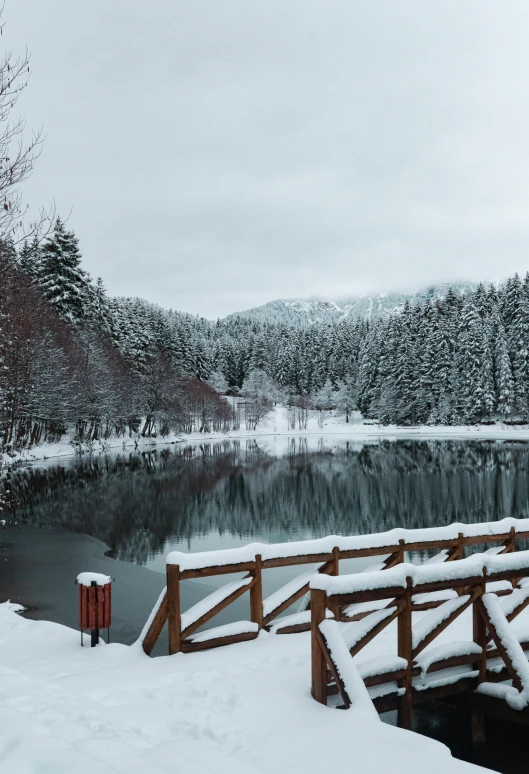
0;437;529;774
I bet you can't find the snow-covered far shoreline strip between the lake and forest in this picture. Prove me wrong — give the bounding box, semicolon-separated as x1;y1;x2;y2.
0;406;529;468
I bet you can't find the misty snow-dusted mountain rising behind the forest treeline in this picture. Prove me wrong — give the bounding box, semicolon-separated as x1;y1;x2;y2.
225;282;477;327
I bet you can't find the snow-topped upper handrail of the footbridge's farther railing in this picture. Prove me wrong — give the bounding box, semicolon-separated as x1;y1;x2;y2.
166;518;529;579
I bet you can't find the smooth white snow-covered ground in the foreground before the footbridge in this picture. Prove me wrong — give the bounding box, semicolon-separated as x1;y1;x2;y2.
0;603;485;774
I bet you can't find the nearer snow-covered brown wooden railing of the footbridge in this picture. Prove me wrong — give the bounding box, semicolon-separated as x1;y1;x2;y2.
310;551;529;740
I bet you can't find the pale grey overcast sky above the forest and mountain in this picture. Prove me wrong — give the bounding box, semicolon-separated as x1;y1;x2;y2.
8;0;529;318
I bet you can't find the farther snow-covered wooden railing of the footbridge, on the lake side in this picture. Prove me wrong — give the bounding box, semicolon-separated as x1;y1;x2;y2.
140;519;529;654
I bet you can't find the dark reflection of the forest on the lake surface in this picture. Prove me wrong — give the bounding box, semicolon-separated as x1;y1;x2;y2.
7;440;529;563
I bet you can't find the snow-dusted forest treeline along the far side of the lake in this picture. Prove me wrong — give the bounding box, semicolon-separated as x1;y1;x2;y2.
0;219;529;447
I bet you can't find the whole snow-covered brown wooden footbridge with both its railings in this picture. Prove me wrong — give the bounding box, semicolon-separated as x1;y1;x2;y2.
140;519;529;741
